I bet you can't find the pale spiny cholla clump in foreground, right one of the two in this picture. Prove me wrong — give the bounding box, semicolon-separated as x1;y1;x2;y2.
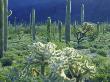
49;47;96;82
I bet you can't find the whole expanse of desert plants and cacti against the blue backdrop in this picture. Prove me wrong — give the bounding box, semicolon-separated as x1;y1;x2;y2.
0;0;110;82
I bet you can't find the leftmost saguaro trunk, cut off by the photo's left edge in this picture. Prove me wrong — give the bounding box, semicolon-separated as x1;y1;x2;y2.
0;0;4;58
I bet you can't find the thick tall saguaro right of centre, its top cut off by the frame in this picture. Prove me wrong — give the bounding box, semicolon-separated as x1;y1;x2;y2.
65;0;71;44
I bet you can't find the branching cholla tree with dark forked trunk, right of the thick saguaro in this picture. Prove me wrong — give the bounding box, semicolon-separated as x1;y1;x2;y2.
73;23;97;47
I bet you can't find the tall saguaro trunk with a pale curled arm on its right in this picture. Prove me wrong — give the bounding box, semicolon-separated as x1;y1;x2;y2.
4;0;8;51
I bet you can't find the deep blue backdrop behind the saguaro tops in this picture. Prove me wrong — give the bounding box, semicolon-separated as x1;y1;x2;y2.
9;0;110;22
